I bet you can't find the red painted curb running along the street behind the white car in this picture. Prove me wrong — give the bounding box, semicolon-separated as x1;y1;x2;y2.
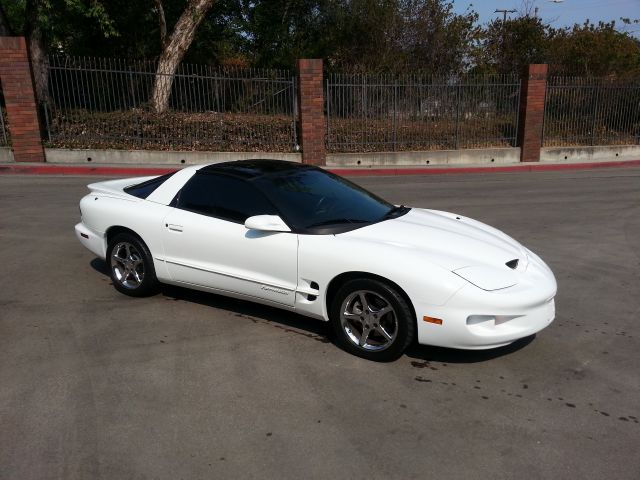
0;160;640;177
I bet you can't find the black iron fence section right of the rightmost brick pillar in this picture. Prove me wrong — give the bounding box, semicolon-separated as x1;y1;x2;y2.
544;77;640;147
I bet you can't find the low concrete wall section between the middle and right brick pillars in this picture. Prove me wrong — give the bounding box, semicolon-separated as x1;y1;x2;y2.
327;148;520;167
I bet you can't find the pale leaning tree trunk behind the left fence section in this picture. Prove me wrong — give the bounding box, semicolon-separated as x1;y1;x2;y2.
151;0;214;113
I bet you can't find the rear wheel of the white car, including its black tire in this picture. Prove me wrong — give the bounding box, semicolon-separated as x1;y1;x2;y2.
106;233;159;297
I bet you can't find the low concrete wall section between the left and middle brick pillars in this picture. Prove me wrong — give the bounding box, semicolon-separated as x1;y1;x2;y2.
44;148;302;165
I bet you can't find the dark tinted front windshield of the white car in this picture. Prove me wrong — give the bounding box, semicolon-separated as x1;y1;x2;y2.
255;168;397;233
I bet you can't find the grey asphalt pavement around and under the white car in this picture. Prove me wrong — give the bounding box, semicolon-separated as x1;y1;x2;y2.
0;168;640;480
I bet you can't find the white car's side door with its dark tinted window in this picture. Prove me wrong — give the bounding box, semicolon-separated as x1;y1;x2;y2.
162;173;298;306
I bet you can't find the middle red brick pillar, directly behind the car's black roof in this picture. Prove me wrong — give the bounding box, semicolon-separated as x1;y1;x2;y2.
298;59;326;165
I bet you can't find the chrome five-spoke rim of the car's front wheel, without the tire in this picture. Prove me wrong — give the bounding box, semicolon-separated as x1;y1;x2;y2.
340;290;398;351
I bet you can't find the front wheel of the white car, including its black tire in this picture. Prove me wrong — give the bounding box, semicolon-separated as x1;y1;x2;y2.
329;279;416;362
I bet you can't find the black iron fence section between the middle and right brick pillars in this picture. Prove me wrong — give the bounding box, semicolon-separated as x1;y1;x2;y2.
326;74;520;152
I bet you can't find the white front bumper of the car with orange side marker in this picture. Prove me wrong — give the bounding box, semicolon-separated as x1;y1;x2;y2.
414;249;557;350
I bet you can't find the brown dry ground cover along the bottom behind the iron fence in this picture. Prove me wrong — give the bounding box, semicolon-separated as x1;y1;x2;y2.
42;109;639;152
